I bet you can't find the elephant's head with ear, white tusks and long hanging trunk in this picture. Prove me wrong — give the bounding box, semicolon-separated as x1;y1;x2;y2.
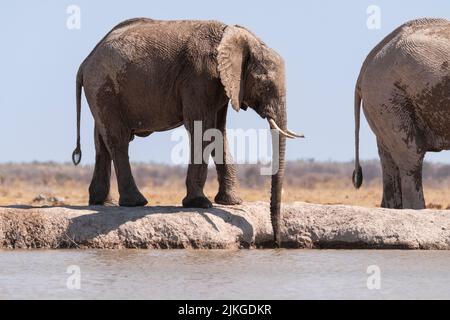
217;26;303;246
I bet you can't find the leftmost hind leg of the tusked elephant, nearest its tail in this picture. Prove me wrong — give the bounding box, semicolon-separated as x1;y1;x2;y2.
89;127;112;205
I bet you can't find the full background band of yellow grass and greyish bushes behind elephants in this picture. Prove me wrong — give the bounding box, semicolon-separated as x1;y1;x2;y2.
0;161;450;209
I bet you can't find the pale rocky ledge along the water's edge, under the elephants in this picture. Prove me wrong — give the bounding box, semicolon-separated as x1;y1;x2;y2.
0;202;450;250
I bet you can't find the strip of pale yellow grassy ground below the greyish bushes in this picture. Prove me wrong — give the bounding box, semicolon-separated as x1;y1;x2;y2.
0;181;450;209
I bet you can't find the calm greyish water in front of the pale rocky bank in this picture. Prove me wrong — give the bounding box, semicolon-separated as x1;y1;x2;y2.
0;250;450;299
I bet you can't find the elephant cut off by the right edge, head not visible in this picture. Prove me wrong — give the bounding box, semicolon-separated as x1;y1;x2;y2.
353;19;450;209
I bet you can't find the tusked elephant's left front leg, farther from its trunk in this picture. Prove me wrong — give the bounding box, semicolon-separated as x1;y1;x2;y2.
183;120;214;208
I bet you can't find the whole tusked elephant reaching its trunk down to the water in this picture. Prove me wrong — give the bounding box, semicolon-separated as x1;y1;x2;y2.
72;18;302;245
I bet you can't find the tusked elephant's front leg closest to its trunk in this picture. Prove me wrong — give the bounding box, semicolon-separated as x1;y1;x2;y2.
212;104;242;205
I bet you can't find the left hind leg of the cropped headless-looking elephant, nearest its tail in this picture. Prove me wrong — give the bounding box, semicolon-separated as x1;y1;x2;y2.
378;141;402;209
